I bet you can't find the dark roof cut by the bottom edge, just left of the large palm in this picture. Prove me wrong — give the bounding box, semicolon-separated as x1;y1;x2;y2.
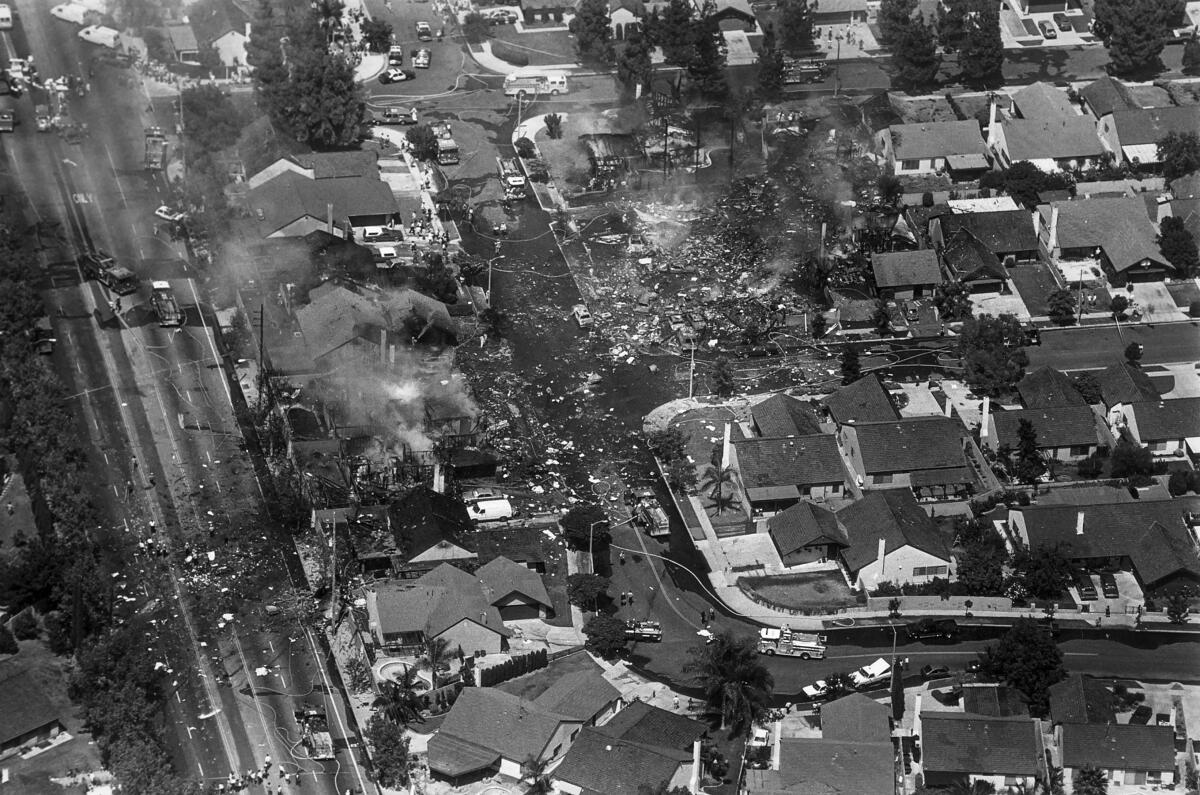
552;728;691;795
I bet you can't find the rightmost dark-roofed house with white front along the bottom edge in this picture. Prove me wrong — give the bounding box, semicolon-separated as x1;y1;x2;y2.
1055;723;1175;789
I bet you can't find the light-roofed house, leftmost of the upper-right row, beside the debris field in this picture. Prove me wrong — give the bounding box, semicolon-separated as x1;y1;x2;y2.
875;119;991;177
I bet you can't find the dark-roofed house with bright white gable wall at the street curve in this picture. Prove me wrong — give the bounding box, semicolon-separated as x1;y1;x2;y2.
836;490;950;590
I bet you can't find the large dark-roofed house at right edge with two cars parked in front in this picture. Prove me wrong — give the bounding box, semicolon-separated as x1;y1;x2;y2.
1007;496;1200;594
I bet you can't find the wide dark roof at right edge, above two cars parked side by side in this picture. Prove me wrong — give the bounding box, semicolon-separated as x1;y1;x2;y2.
1015;497;1200;587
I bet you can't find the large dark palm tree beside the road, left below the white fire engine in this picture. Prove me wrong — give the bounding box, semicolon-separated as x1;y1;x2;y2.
684;632;775;736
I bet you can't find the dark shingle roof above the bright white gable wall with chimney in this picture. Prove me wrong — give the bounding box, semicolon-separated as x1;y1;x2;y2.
836;489;950;573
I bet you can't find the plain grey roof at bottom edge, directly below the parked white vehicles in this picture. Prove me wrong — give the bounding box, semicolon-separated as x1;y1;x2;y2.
746;737;895;795
